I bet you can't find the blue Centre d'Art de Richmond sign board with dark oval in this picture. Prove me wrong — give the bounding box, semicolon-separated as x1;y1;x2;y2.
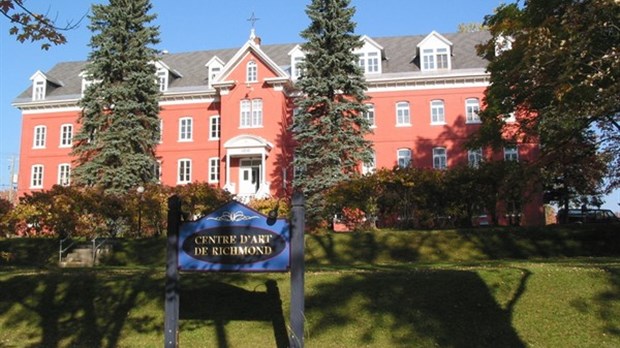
178;201;291;272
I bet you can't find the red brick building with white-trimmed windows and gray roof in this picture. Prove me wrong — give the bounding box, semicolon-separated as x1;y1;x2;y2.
13;31;542;224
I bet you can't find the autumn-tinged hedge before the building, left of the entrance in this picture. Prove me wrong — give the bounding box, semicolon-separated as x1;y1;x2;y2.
0;183;231;238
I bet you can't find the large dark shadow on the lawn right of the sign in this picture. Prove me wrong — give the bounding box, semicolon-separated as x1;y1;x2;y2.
306;270;527;347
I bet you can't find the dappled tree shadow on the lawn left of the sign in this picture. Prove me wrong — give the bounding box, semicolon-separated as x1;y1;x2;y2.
0;270;161;348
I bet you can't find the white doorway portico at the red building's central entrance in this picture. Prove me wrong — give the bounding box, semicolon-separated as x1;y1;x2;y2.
224;134;273;201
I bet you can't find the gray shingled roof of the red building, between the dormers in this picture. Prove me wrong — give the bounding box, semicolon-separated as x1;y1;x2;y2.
14;31;490;102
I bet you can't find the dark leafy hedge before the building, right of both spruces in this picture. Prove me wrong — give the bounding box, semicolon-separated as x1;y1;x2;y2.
326;161;535;228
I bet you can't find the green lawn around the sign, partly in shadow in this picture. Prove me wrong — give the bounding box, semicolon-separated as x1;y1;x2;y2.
0;227;620;348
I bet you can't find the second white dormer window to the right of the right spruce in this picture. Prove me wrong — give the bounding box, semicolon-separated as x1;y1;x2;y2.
417;31;452;71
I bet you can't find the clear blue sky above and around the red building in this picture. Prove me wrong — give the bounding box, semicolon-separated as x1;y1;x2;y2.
0;0;620;211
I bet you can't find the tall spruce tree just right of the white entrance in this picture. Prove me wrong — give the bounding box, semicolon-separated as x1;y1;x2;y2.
293;0;372;222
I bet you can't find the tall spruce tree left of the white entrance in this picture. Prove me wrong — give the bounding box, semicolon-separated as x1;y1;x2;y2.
73;0;159;193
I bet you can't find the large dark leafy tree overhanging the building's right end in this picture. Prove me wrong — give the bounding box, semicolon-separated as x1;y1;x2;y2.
474;0;620;194
